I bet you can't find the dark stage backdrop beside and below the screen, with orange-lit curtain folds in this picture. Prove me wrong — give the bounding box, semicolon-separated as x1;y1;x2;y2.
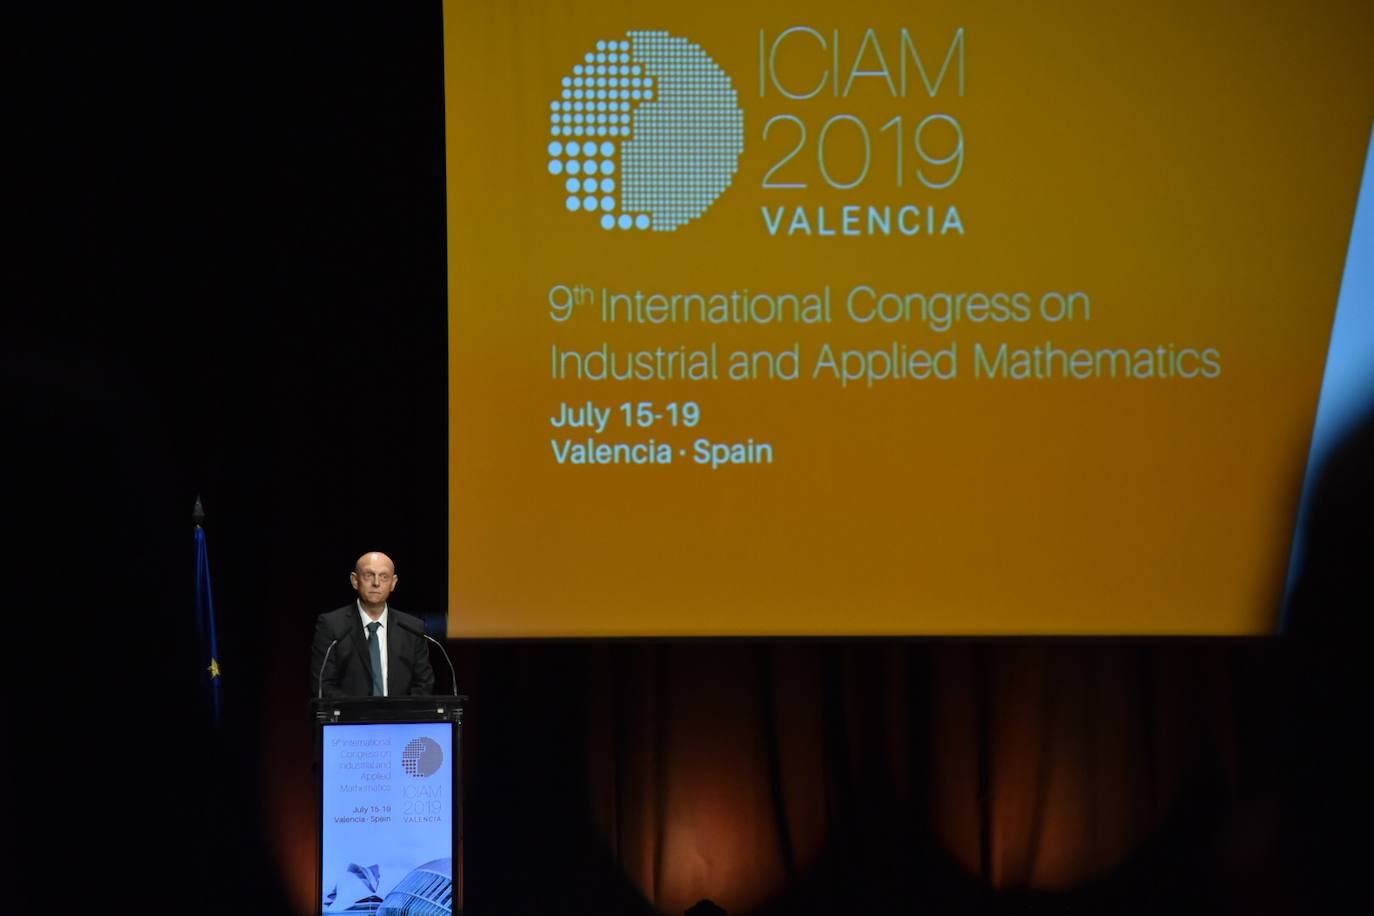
18;3;1371;913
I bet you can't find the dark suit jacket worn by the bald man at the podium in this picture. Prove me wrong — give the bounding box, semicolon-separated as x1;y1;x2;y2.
311;602;434;698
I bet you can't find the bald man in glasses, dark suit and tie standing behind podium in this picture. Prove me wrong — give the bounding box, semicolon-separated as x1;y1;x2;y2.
311;552;434;698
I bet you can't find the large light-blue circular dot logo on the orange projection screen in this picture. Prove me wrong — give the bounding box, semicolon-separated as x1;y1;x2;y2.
547;32;745;232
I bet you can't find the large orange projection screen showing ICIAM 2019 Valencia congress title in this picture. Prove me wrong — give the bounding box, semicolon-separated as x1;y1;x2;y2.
444;0;1374;637
